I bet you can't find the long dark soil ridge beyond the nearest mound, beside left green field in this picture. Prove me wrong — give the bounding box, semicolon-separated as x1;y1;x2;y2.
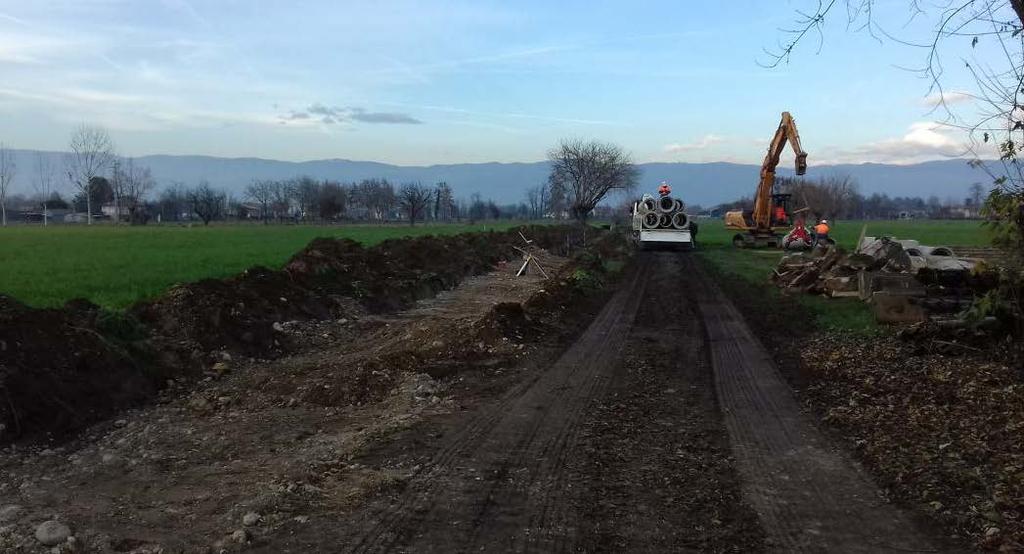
132;226;573;357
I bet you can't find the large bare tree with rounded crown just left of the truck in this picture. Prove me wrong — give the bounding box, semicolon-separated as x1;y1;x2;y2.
548;139;639;222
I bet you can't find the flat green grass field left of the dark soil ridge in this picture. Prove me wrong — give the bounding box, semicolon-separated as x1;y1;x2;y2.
0;223;515;309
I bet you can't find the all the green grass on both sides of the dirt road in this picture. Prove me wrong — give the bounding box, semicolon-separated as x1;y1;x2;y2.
0;220;987;317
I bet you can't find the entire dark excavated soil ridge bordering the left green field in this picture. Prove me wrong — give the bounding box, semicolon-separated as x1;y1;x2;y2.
0;222;580;442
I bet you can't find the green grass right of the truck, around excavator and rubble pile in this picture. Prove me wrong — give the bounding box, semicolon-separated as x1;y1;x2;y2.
697;220;988;332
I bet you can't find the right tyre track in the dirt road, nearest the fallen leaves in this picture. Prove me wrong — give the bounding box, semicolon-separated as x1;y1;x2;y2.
690;257;943;553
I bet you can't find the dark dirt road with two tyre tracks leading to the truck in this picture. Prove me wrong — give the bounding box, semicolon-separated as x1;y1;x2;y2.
315;253;939;552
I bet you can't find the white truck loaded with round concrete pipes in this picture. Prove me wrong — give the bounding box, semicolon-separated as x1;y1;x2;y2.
633;195;697;250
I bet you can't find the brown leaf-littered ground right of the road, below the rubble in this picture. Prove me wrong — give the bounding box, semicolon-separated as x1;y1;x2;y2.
803;336;1024;552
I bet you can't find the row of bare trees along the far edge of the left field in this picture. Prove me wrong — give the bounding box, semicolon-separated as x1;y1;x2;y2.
0;125;638;224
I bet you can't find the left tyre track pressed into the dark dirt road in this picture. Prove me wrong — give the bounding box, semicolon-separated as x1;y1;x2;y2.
342;261;649;552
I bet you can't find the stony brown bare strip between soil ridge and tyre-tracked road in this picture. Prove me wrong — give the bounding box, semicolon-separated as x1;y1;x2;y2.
0;230;583;552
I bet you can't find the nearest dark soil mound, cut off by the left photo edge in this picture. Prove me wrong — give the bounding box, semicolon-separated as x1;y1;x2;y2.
0;296;161;442
